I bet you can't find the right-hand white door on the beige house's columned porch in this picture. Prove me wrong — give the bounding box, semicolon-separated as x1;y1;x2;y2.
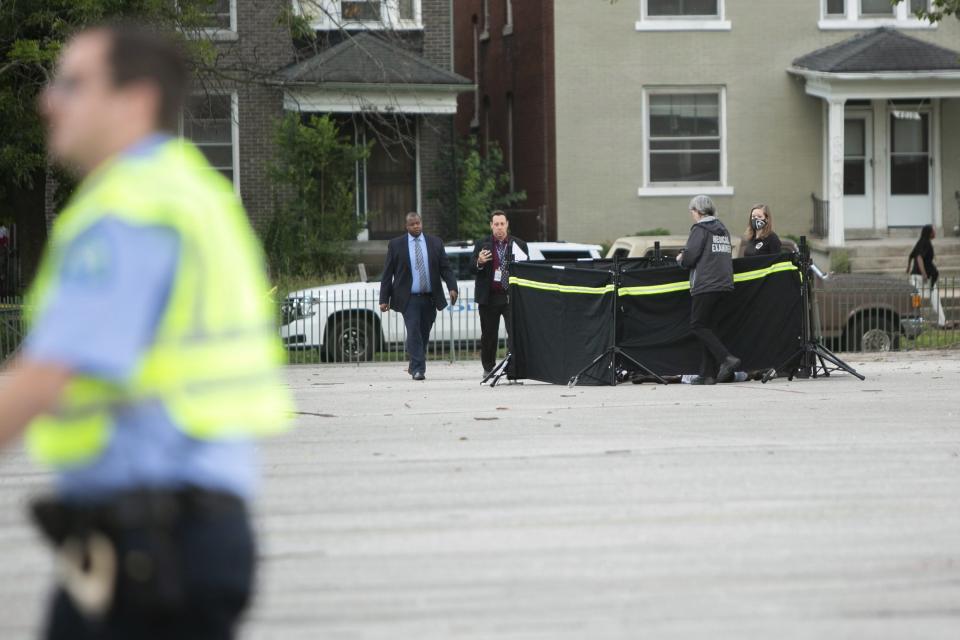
887;111;933;227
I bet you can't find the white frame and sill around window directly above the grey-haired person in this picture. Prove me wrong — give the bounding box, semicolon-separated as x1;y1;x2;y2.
637;85;734;197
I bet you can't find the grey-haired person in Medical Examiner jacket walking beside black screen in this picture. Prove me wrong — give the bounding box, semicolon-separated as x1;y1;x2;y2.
677;196;740;384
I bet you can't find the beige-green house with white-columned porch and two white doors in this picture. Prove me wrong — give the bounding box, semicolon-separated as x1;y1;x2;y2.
554;0;960;247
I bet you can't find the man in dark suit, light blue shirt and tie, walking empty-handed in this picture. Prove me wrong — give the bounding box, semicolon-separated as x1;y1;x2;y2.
380;212;457;380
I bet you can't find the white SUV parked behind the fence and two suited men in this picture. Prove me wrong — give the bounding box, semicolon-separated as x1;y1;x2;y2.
280;242;601;362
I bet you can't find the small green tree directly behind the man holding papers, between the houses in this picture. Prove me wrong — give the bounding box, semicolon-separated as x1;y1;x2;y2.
431;136;527;239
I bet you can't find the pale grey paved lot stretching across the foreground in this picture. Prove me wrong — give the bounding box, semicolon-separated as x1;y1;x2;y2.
0;352;960;640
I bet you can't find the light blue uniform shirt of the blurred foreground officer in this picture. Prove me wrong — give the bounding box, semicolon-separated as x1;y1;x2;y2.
24;148;257;500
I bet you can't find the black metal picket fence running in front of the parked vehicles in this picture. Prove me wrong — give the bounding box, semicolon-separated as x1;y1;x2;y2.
0;274;960;364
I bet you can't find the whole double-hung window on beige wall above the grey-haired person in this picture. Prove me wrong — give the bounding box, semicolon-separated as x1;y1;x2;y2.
641;89;732;195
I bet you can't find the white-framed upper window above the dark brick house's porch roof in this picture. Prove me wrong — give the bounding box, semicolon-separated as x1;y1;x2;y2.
293;0;422;30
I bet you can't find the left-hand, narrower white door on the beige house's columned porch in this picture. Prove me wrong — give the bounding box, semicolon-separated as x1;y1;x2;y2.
843;113;874;229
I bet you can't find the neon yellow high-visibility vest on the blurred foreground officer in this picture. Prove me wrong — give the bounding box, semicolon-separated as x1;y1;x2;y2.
27;139;293;468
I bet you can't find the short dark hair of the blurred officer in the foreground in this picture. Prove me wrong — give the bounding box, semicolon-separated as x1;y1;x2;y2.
92;22;191;133
